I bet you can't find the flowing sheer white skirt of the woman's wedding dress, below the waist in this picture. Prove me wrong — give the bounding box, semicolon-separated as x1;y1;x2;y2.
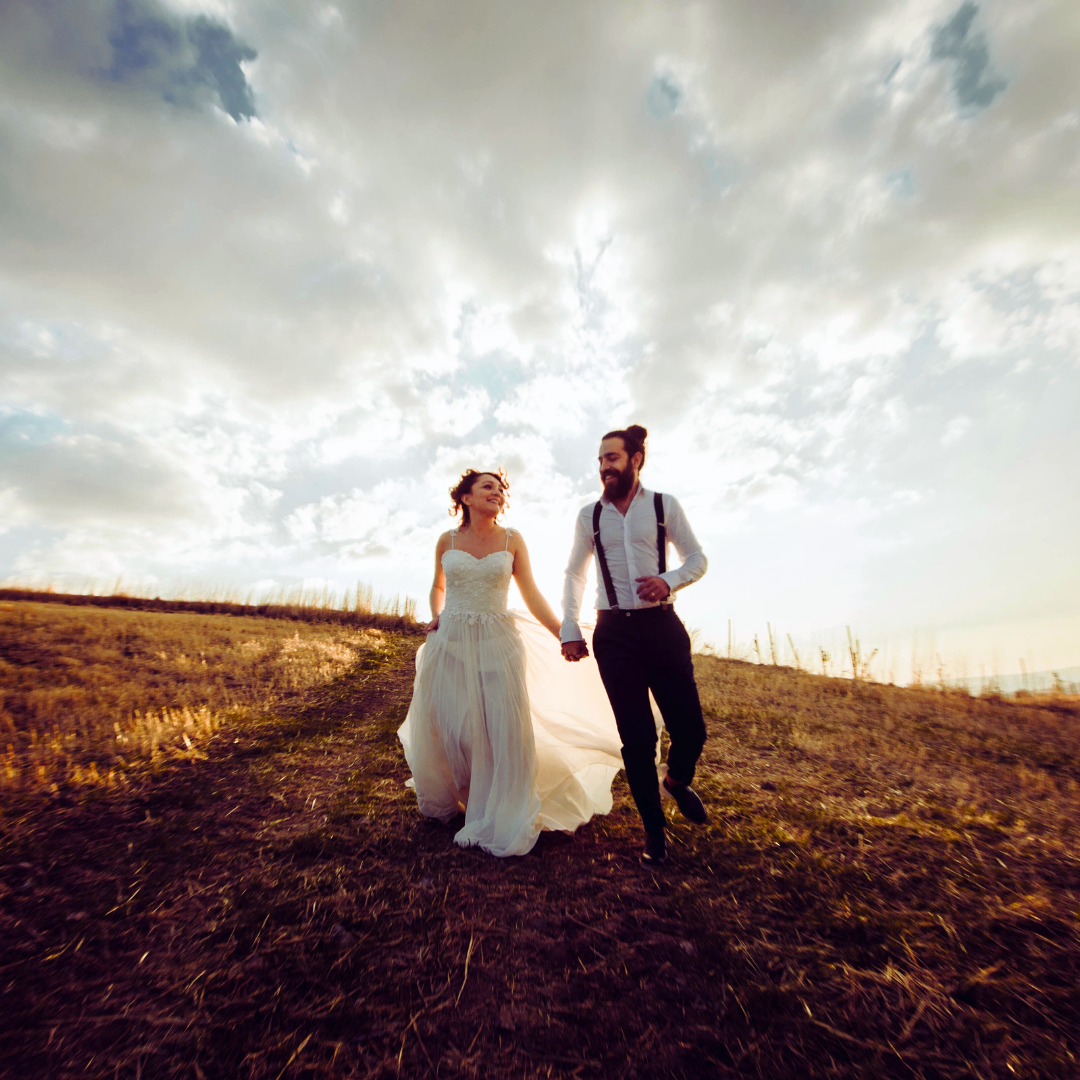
397;611;622;855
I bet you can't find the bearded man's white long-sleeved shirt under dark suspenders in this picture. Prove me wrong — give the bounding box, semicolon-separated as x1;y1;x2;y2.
559;486;708;642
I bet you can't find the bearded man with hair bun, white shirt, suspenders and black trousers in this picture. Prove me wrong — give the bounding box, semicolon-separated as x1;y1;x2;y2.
561;424;707;865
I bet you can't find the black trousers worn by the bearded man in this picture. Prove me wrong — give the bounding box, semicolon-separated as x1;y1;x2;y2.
593;607;705;832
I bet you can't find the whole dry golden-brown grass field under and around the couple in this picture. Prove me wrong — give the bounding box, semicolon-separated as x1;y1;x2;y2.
0;605;1080;1080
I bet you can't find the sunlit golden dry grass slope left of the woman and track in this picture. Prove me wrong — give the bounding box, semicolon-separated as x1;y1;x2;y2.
0;603;401;791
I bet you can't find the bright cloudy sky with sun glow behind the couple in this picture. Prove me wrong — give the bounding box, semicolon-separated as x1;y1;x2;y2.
0;0;1080;680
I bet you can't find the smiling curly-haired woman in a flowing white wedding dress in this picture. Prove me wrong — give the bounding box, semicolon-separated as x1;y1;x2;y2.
397;470;622;855
